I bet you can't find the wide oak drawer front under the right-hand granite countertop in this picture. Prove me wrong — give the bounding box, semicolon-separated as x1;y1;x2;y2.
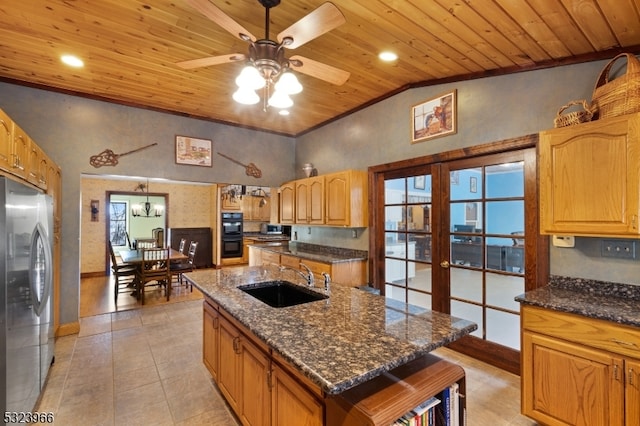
522;306;640;358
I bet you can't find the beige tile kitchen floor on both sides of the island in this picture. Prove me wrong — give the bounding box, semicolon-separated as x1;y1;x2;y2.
38;284;535;426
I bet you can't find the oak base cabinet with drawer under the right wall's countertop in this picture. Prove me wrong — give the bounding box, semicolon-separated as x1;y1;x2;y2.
521;305;640;426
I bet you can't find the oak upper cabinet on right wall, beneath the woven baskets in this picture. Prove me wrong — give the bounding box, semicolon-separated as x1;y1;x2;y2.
539;114;640;238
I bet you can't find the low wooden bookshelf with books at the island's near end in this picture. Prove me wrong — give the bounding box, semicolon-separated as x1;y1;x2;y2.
326;354;466;426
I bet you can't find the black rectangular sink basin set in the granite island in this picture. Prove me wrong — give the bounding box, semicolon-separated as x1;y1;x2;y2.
238;280;328;308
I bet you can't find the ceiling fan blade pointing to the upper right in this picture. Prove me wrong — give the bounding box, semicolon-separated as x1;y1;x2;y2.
278;2;347;49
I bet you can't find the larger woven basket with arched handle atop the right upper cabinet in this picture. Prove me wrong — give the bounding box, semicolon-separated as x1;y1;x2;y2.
592;53;640;118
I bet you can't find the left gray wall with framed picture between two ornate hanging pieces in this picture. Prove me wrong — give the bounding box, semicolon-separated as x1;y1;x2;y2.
0;83;295;324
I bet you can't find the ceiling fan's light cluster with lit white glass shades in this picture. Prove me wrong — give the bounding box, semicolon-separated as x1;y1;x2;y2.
233;38;302;111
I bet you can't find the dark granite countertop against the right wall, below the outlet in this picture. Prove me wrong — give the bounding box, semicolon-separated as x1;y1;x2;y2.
515;276;640;327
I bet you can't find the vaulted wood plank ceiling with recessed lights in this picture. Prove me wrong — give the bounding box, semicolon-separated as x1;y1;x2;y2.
0;0;640;136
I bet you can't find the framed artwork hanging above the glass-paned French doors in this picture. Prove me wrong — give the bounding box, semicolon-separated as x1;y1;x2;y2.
411;90;458;143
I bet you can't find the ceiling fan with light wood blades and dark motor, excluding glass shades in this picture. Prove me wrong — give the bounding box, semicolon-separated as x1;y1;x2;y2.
176;0;351;108
